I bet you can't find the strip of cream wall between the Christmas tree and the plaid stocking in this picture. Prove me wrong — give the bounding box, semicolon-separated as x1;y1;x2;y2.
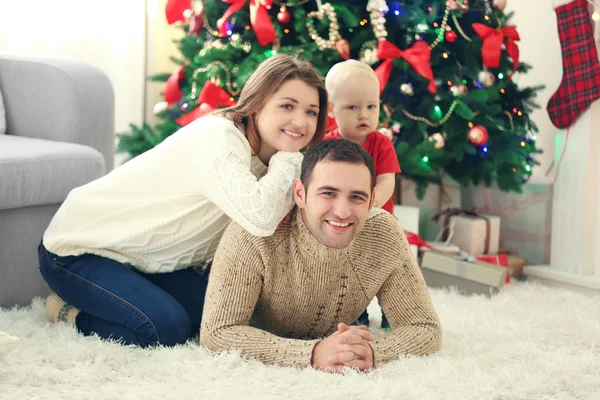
506;0;562;178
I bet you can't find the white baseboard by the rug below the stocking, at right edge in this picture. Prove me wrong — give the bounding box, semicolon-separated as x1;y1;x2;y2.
524;265;600;295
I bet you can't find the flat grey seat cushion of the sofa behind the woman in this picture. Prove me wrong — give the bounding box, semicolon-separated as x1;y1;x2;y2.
0;135;104;210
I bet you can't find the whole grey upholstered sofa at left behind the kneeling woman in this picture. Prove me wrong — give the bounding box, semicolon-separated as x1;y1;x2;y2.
0;53;115;308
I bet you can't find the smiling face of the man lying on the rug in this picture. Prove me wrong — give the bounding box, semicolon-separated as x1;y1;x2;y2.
294;160;374;249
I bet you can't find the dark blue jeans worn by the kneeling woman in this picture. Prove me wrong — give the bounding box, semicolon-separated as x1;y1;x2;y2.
38;244;208;347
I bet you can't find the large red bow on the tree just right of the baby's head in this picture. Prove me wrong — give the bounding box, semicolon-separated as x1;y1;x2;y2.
375;40;437;94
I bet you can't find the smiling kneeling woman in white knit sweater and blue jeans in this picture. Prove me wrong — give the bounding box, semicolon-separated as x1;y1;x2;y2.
39;54;327;347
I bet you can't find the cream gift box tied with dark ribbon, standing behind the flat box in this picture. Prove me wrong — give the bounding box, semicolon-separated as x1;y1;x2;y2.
440;215;500;254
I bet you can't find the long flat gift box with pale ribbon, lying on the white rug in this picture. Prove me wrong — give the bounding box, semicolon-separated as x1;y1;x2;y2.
421;251;507;296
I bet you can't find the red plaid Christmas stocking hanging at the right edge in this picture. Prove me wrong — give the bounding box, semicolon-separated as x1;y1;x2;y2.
547;0;600;129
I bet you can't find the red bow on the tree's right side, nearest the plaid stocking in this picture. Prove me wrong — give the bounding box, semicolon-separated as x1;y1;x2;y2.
471;23;521;75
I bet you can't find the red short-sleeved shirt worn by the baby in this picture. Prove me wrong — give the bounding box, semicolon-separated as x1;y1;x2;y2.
325;129;401;215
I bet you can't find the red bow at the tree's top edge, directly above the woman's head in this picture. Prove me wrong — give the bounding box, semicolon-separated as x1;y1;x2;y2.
217;0;277;46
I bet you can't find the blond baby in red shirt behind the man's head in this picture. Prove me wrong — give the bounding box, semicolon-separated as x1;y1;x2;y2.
325;60;400;330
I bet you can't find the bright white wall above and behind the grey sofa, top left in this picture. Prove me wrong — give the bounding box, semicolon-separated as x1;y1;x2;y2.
0;0;146;132
